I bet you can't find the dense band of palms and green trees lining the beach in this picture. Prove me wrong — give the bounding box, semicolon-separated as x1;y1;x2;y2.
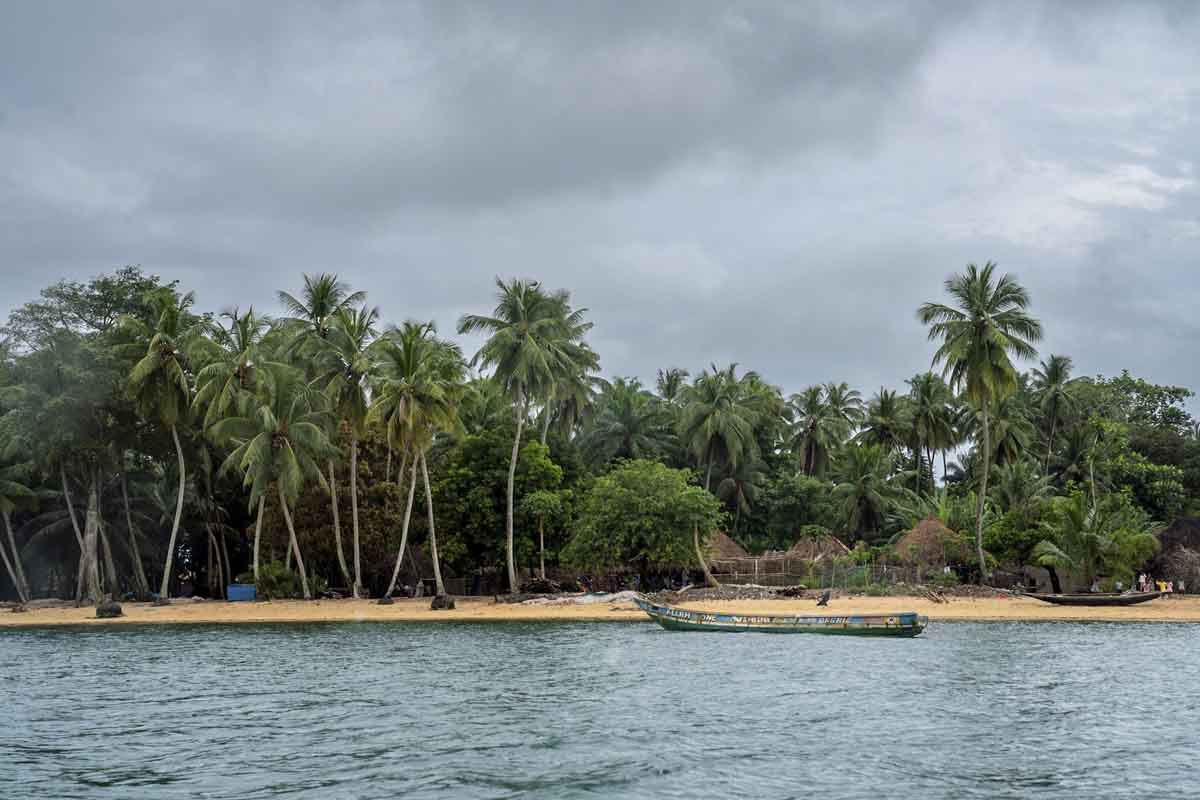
0;264;1200;600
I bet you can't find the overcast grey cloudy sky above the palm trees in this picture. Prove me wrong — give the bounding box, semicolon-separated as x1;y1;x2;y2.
0;0;1200;395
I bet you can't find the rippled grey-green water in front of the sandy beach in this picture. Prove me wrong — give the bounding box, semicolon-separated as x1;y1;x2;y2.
0;624;1200;800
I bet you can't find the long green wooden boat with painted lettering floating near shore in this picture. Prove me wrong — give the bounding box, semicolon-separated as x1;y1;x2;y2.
634;597;929;638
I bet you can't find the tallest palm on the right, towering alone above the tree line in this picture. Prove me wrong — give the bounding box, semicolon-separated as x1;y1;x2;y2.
917;261;1042;579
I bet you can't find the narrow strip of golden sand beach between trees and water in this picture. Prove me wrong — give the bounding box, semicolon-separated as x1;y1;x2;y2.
0;595;1200;628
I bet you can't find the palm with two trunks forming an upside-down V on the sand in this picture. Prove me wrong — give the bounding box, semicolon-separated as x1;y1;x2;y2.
372;321;467;596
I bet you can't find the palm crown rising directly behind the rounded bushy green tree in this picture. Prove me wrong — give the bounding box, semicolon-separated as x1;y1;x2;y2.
582;378;671;464
